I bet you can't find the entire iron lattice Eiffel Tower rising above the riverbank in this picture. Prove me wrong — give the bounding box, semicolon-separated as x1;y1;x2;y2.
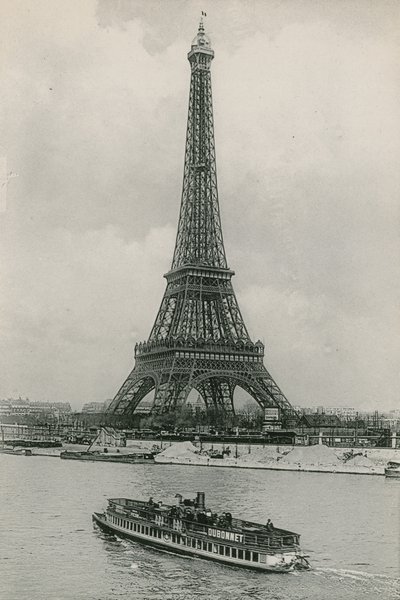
107;21;292;416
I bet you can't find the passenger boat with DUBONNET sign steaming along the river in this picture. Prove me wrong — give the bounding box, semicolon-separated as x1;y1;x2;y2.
92;492;310;573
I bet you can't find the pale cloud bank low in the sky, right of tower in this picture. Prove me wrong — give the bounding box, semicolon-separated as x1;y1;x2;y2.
239;285;400;410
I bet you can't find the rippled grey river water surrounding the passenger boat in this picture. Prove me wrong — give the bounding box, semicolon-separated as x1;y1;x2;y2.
0;455;400;600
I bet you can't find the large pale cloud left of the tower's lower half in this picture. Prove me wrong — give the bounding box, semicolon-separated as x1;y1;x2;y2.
0;226;174;406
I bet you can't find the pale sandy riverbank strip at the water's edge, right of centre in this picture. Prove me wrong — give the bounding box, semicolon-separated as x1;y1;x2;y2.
155;442;400;475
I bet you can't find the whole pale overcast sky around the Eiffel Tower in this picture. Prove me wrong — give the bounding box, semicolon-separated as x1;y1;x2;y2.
0;0;400;410
